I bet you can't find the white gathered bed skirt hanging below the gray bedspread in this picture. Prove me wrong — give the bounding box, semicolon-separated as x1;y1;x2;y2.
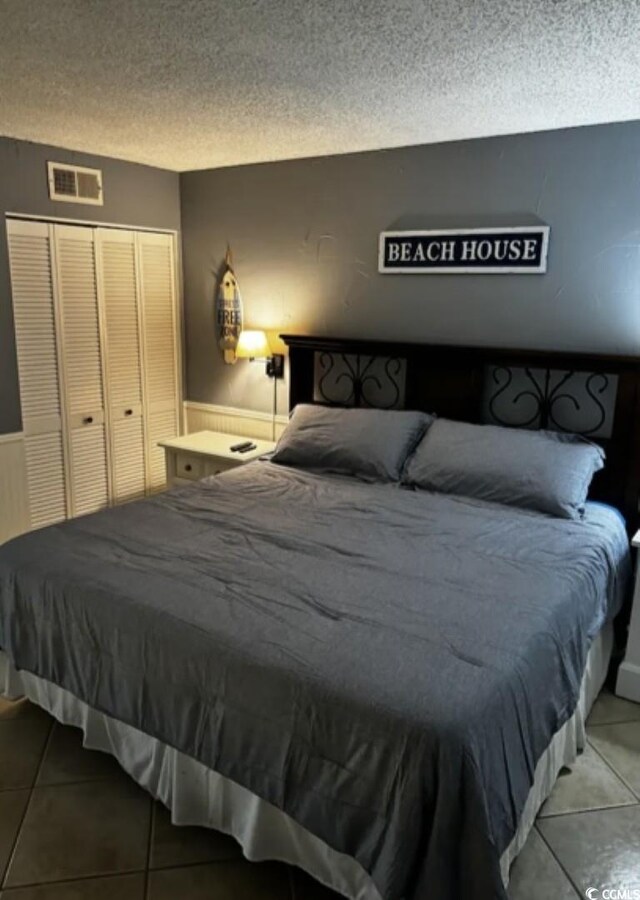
0;625;613;900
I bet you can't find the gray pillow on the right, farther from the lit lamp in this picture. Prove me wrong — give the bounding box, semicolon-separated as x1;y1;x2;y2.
402;419;604;519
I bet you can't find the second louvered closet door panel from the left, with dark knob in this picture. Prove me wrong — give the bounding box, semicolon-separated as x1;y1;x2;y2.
54;225;109;516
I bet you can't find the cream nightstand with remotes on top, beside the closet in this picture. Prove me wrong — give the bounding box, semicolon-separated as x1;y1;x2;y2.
158;431;276;487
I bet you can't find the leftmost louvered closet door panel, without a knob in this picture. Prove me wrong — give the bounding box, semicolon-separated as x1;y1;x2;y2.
7;219;67;528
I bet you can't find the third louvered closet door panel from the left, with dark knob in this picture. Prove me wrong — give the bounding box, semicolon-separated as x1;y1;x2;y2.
96;228;146;503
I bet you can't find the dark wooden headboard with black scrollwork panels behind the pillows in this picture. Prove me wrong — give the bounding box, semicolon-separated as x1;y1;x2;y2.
281;334;640;532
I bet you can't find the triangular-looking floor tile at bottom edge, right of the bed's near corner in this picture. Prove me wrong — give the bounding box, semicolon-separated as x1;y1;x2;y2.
509;828;577;900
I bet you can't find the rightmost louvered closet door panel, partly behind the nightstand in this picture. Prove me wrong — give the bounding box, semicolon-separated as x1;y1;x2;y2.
136;232;178;490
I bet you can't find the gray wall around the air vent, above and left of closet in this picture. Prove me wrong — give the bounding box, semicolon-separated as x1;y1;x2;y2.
0;138;180;434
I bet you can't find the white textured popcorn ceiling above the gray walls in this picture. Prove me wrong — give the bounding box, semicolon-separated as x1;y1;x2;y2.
0;0;640;170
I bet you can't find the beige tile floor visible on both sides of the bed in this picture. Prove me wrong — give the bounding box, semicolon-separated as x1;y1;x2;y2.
0;692;640;900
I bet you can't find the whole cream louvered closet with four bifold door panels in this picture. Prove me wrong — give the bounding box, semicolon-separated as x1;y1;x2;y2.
7;219;179;528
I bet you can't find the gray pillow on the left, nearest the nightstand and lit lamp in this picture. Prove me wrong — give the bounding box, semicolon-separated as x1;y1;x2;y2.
272;403;433;481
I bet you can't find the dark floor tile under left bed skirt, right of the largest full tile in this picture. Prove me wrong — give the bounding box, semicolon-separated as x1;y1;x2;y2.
150;803;242;869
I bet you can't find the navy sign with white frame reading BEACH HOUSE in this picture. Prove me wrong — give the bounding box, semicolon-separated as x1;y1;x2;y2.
378;225;549;275
